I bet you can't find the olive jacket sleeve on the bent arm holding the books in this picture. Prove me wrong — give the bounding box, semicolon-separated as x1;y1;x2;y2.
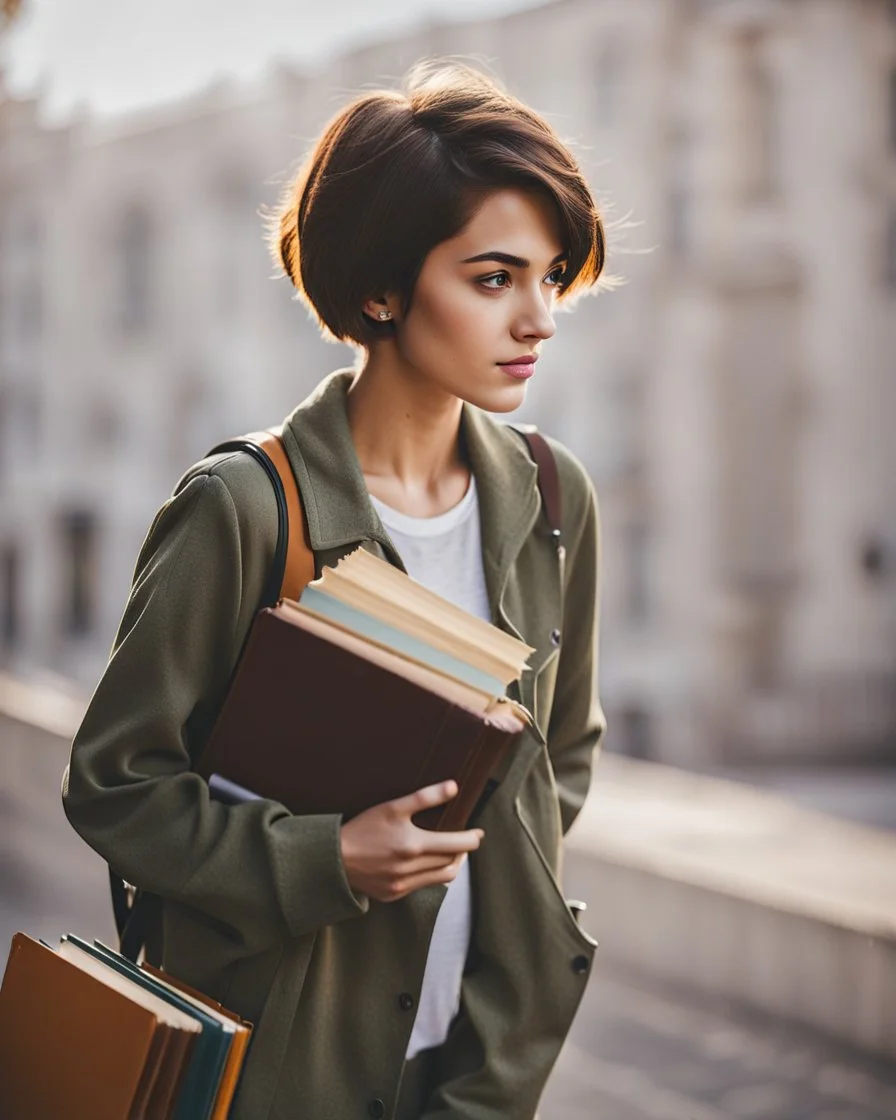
63;460;367;952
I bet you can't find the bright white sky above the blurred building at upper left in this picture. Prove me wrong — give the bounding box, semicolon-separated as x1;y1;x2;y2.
0;0;549;120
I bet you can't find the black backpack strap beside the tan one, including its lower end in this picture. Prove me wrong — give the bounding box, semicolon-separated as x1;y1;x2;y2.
109;433;289;965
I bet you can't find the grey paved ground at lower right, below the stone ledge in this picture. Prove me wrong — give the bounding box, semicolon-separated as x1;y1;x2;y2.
540;951;896;1120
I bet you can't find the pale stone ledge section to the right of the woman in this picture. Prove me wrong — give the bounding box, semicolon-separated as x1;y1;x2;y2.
564;755;896;1056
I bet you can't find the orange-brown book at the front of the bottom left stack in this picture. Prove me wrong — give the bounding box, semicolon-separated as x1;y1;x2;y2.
0;933;197;1120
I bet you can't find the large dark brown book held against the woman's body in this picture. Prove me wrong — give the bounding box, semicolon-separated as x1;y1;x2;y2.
196;604;524;830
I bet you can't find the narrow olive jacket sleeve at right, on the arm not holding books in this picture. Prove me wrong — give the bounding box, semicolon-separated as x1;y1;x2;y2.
547;440;606;833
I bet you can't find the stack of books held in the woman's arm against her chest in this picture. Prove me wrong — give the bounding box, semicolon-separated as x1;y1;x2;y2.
196;549;533;830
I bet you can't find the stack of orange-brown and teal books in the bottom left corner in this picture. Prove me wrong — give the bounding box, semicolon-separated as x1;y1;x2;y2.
0;933;252;1120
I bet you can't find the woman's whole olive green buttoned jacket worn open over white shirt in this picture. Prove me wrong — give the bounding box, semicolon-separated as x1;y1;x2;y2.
63;370;604;1120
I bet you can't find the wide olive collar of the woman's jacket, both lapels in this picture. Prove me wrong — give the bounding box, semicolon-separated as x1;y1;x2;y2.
283;370;540;614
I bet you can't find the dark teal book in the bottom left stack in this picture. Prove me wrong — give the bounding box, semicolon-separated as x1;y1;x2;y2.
63;933;233;1120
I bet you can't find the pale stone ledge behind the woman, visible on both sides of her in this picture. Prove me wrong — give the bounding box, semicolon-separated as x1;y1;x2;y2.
0;673;896;1057
